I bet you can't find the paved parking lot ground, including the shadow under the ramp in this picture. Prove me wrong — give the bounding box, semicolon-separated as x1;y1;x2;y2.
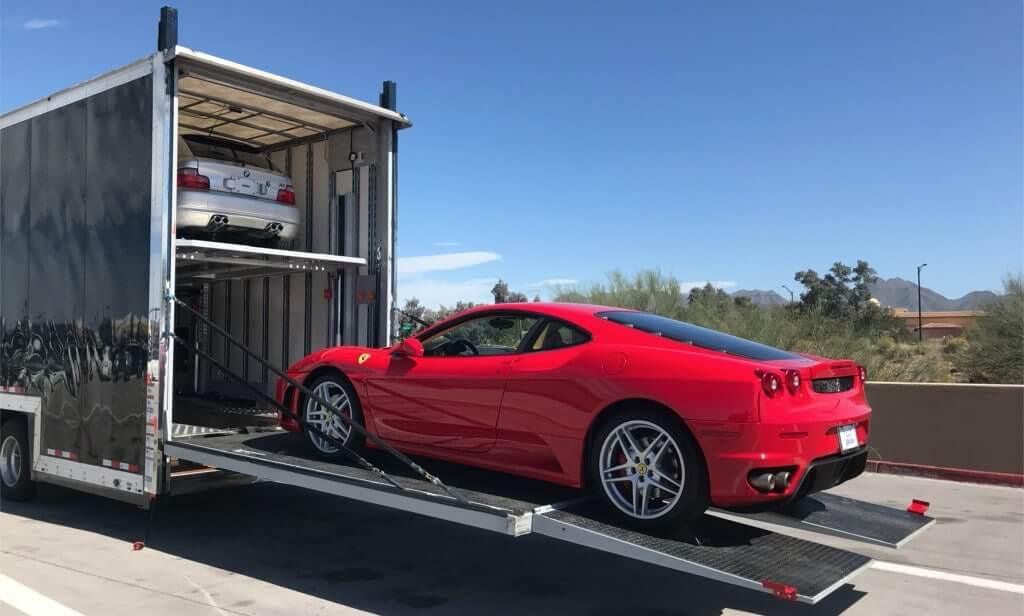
0;475;1024;616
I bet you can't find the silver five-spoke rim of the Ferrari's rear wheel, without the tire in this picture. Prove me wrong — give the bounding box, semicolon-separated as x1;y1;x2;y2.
598;420;686;520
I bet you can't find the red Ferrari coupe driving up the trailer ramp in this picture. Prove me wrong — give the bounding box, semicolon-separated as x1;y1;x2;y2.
276;303;871;528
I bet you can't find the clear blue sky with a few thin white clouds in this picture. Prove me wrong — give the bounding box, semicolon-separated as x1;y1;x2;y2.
0;0;1024;304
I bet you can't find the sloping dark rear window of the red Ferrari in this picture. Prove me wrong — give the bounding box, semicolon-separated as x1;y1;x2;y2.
597;311;801;361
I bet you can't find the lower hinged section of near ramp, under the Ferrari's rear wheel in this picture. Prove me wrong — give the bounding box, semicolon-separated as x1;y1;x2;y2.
532;501;871;604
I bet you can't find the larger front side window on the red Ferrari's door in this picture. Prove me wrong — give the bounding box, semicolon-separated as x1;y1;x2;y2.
423;314;537;357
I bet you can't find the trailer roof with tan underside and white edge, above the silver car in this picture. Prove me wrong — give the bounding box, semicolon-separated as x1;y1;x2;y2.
168;46;411;148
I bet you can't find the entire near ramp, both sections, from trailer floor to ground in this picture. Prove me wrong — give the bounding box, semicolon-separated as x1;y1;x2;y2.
165;430;888;604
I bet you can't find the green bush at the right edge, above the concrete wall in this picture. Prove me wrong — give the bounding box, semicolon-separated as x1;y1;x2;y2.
953;274;1024;383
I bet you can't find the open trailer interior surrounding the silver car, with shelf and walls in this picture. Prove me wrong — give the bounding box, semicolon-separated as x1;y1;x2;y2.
169;47;409;434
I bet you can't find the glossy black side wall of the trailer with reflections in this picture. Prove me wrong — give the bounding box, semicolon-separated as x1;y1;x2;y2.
0;77;158;471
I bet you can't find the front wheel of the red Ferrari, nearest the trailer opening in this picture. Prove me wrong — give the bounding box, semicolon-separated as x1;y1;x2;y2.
302;373;362;459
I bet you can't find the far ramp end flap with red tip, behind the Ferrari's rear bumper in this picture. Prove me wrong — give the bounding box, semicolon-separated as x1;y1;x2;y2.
713;492;935;549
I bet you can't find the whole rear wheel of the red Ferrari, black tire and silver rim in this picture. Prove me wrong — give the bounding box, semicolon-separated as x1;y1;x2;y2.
590;410;708;529
